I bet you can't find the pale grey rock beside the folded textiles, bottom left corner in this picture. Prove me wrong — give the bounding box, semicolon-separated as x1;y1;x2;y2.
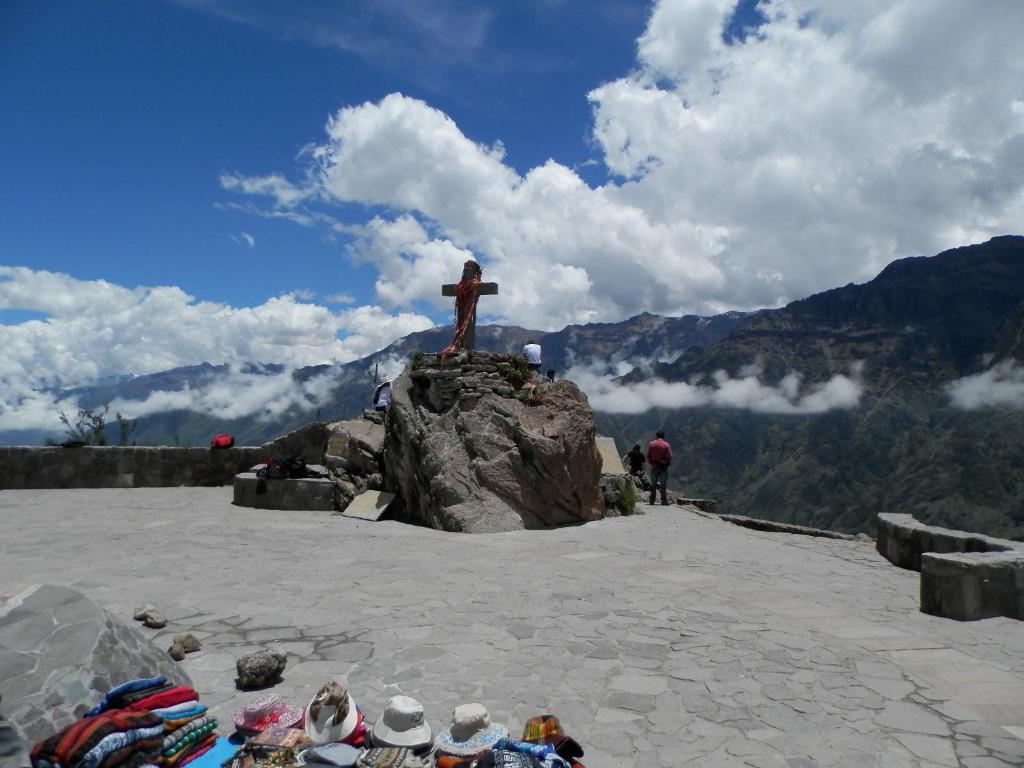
0;585;191;743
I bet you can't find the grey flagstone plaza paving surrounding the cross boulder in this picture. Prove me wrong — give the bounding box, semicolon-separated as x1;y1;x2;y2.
0;487;1024;768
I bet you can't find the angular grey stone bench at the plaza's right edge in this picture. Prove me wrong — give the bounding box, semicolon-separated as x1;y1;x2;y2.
876;514;1024;622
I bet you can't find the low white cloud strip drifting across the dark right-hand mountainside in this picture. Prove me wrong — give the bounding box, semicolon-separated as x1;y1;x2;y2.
565;364;863;416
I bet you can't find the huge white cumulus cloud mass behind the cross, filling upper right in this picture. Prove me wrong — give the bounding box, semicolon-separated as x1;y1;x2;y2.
226;0;1024;329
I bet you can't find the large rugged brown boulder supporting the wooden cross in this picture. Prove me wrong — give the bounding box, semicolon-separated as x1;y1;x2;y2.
384;351;603;532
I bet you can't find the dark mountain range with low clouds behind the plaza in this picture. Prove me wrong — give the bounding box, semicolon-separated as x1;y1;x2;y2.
6;236;1024;539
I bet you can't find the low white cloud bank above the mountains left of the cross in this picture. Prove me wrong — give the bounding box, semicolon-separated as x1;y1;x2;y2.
0;266;433;429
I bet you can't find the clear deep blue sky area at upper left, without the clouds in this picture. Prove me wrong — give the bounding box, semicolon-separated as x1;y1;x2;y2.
0;0;646;313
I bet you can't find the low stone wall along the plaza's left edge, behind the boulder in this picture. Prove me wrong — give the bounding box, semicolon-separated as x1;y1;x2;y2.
0;422;327;489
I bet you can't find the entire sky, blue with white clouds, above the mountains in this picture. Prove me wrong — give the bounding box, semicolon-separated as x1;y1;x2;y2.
0;0;1024;426
